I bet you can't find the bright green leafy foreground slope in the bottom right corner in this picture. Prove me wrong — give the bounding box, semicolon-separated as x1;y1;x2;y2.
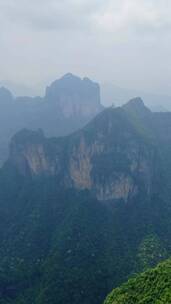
104;260;171;304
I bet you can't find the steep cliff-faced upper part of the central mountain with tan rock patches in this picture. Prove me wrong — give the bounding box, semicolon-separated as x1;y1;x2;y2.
7;101;156;202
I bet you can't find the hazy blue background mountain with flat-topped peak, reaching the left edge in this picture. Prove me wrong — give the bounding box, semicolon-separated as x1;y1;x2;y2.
0;74;103;165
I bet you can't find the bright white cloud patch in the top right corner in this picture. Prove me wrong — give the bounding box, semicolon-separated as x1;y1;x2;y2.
94;0;171;33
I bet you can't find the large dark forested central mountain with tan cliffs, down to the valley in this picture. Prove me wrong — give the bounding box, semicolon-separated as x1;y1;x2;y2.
0;98;171;304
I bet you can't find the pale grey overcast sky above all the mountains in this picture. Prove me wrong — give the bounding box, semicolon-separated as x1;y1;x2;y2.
0;0;171;94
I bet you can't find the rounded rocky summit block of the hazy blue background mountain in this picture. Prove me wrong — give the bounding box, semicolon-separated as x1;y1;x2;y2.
45;74;102;118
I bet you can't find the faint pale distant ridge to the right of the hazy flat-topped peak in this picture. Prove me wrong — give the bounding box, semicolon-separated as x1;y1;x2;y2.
100;83;171;112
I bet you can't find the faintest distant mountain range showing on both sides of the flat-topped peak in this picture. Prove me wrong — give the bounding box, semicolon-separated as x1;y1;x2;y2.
0;76;171;112
